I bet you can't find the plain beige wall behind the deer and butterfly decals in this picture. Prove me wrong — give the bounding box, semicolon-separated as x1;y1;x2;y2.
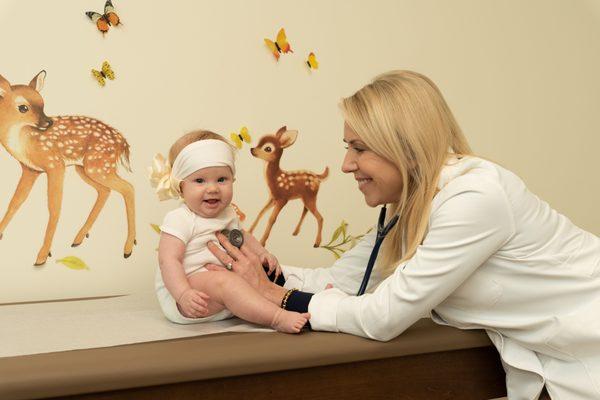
0;0;600;302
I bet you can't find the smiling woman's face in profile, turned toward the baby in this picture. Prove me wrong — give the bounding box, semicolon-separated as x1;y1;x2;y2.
342;123;402;207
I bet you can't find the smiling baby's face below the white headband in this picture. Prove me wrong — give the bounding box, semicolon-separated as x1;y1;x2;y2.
181;167;234;218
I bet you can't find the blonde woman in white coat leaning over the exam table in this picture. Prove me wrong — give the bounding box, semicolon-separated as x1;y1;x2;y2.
205;71;600;400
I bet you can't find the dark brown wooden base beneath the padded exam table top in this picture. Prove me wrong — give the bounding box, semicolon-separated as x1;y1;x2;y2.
62;346;506;400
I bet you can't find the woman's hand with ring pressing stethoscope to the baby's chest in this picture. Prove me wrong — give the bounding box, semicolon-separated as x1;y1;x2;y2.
205;232;270;291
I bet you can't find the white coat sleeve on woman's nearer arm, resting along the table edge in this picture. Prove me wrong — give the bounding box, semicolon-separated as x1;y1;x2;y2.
308;177;514;341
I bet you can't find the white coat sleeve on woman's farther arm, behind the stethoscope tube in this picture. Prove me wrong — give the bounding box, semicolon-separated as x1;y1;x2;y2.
282;229;382;294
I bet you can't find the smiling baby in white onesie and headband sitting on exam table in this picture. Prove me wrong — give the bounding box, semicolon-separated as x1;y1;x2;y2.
153;131;310;333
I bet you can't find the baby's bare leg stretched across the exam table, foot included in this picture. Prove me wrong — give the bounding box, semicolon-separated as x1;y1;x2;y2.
189;271;310;333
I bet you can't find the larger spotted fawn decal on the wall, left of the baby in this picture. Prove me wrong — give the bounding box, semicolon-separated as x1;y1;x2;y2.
0;71;135;265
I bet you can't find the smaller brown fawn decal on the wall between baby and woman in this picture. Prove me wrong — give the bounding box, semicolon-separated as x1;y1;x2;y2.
250;126;329;247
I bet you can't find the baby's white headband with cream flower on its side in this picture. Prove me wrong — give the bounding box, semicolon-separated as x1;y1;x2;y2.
148;139;235;200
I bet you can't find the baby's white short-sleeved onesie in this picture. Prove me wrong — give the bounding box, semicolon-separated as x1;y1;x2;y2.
155;203;240;324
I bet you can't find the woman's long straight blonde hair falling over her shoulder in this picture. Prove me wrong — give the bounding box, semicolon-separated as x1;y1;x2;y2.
340;71;473;275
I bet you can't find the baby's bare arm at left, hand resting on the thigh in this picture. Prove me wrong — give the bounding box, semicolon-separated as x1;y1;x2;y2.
158;232;209;318
